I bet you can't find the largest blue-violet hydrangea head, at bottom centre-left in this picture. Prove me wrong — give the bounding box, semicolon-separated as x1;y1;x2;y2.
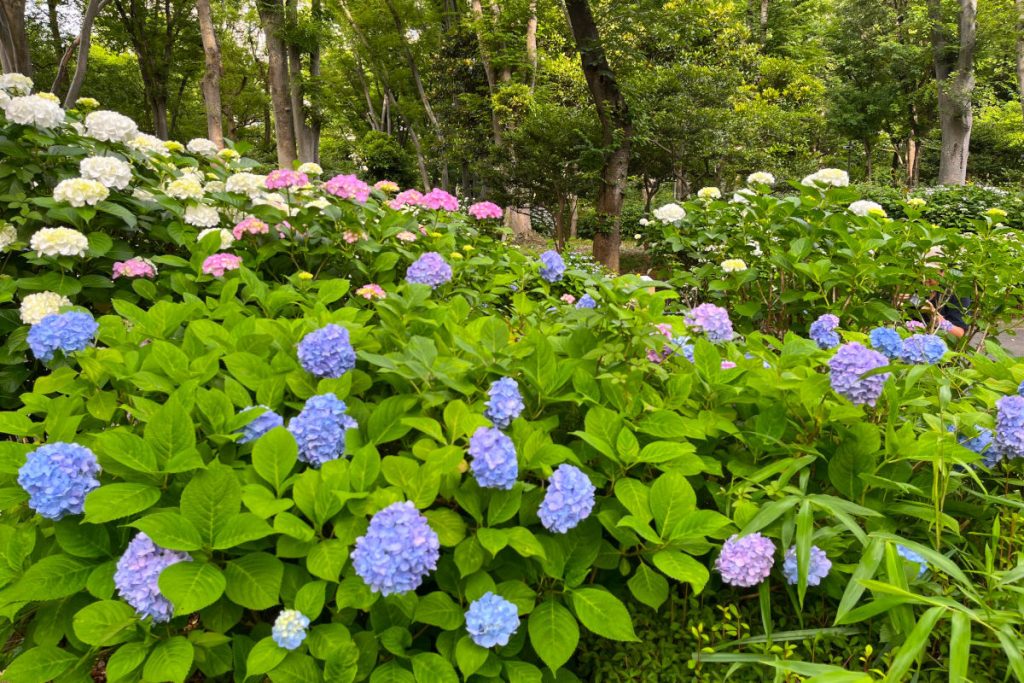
352;502;440;595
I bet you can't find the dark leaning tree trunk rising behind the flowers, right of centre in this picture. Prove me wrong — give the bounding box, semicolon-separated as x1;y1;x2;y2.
565;0;633;271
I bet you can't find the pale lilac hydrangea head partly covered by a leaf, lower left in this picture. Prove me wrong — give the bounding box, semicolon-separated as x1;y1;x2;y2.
114;531;191;624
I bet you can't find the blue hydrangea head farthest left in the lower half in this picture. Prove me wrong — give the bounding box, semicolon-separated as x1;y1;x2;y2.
17;441;99;519
